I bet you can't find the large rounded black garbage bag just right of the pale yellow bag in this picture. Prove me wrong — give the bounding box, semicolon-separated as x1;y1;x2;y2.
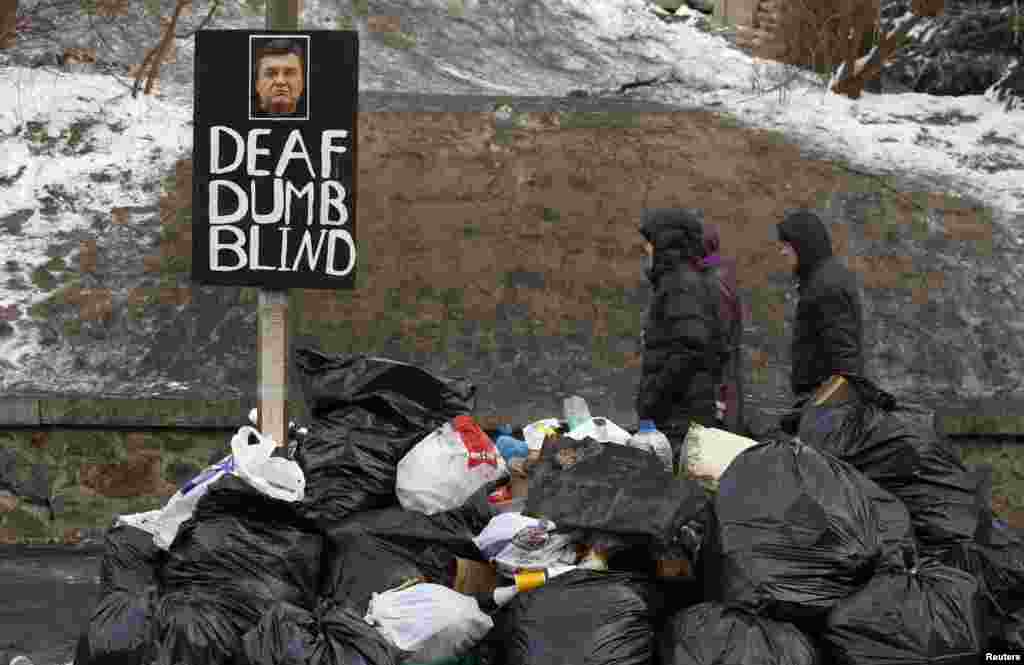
703;442;882;622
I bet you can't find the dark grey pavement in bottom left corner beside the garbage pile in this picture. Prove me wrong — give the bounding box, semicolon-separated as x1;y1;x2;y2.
0;546;100;665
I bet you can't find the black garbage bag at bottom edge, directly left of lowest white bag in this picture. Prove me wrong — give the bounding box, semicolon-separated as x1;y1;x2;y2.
242;601;402;665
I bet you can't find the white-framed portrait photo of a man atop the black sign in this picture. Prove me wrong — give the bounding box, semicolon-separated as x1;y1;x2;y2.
249;35;309;120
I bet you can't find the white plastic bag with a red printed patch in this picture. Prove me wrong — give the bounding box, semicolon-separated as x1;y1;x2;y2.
395;416;508;515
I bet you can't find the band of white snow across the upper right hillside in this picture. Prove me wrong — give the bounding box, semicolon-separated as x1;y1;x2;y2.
562;0;1024;218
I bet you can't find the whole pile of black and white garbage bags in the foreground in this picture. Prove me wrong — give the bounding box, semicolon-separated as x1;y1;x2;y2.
75;349;1024;665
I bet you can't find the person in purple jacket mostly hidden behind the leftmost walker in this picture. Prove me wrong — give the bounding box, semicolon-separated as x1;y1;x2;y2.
703;224;743;433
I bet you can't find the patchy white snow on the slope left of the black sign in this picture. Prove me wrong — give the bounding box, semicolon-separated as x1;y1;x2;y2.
0;67;193;377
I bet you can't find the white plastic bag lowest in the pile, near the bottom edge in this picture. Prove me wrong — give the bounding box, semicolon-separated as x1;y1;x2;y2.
366;584;495;663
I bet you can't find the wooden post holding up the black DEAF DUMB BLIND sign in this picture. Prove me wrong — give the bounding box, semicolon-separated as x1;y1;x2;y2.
256;0;300;446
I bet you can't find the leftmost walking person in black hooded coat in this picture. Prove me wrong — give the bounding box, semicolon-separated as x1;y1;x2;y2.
636;208;726;464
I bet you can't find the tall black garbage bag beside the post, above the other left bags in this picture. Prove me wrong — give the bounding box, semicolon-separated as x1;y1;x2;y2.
295;348;476;529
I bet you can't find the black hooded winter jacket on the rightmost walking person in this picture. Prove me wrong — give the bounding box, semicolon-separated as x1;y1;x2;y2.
778;211;864;394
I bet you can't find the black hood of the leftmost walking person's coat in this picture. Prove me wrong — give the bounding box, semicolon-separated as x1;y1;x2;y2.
640;208;705;282
